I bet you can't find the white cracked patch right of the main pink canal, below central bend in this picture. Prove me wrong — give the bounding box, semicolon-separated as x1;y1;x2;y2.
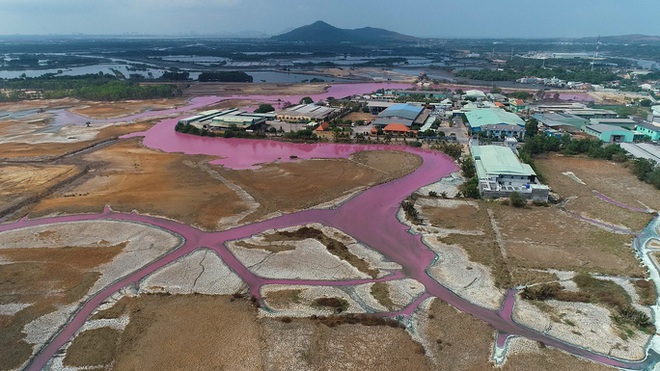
423;236;505;310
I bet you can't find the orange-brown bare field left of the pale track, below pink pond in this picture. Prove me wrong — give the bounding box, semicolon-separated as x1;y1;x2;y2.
23;139;246;229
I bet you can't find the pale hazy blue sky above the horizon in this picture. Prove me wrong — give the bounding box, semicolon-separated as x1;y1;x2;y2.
0;0;660;38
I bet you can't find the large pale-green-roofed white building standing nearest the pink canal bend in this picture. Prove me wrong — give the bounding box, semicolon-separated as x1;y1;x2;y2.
470;142;549;202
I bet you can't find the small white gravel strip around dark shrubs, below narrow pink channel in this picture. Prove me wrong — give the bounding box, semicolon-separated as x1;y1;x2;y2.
259;285;366;317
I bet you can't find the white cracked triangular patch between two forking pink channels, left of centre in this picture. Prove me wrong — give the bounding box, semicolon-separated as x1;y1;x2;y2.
139;249;245;295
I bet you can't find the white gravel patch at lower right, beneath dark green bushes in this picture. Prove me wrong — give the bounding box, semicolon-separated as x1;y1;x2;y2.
513;298;650;360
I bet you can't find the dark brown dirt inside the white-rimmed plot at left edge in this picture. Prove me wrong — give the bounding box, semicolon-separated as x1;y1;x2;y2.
0;244;126;370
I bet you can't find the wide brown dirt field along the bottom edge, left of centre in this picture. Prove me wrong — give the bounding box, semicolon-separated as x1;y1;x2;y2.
65;295;430;370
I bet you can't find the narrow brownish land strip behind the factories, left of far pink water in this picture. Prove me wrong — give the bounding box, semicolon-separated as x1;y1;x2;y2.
184;82;327;97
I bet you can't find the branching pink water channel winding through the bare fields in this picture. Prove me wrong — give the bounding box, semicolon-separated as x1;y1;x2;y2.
6;83;657;370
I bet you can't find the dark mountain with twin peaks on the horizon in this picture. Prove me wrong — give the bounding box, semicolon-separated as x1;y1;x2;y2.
271;21;418;43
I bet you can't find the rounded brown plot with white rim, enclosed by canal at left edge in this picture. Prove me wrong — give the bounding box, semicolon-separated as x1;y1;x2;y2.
0;222;179;369
